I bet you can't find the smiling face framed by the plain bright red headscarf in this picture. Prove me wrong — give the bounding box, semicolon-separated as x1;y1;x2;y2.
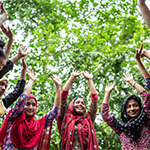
24;98;36;116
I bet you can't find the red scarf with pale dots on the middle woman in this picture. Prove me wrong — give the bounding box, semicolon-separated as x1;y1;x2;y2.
57;99;99;150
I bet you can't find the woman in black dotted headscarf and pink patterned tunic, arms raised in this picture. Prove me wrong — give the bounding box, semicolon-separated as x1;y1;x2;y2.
101;73;150;150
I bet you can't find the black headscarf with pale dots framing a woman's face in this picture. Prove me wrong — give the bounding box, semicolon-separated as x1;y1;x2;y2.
114;95;146;143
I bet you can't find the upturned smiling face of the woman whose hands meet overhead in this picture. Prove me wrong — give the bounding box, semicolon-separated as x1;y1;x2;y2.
74;97;85;115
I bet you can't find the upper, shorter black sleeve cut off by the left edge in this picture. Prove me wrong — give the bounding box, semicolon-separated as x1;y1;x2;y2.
0;60;14;79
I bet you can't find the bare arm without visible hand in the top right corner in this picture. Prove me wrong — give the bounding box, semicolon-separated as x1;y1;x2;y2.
138;0;150;28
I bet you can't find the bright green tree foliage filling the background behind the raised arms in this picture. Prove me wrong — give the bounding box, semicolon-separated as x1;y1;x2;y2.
1;0;150;150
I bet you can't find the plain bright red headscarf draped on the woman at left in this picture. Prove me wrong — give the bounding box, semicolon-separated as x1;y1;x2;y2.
0;95;52;150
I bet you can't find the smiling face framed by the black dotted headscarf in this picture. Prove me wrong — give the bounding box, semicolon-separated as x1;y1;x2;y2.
126;99;141;118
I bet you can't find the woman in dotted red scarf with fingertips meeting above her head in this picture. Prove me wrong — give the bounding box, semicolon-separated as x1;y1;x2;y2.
57;72;99;150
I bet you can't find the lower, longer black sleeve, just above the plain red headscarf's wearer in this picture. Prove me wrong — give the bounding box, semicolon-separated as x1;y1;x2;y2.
2;79;26;108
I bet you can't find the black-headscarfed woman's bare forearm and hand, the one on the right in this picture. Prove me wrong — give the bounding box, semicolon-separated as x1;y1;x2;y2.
123;73;145;94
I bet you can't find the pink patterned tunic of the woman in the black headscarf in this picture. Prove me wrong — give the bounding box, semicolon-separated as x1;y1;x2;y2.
101;90;150;150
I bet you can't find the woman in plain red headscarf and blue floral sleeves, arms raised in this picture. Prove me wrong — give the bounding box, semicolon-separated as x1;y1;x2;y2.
0;70;61;150
